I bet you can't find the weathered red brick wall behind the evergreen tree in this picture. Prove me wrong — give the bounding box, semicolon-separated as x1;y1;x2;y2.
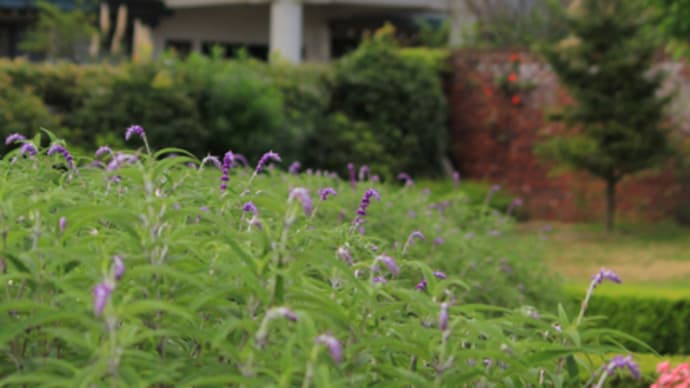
447;50;690;221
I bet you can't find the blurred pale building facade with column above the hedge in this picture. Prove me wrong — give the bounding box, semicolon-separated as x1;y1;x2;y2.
151;0;448;63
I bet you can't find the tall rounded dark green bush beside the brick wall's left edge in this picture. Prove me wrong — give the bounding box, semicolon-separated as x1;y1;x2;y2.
326;31;447;175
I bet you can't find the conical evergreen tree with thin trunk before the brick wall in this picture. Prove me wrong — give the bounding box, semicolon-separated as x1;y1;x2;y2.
537;0;670;230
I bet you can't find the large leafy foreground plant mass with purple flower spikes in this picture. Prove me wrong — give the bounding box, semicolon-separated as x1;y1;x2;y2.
0;132;644;387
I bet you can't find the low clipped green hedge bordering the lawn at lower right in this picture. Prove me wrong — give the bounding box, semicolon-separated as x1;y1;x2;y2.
569;291;690;354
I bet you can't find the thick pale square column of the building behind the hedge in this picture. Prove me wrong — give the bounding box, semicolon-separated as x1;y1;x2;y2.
269;0;302;63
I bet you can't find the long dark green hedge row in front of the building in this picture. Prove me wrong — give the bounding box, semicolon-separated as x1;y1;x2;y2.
0;38;446;177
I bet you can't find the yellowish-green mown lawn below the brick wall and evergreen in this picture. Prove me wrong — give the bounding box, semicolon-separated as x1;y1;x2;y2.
517;222;690;286
